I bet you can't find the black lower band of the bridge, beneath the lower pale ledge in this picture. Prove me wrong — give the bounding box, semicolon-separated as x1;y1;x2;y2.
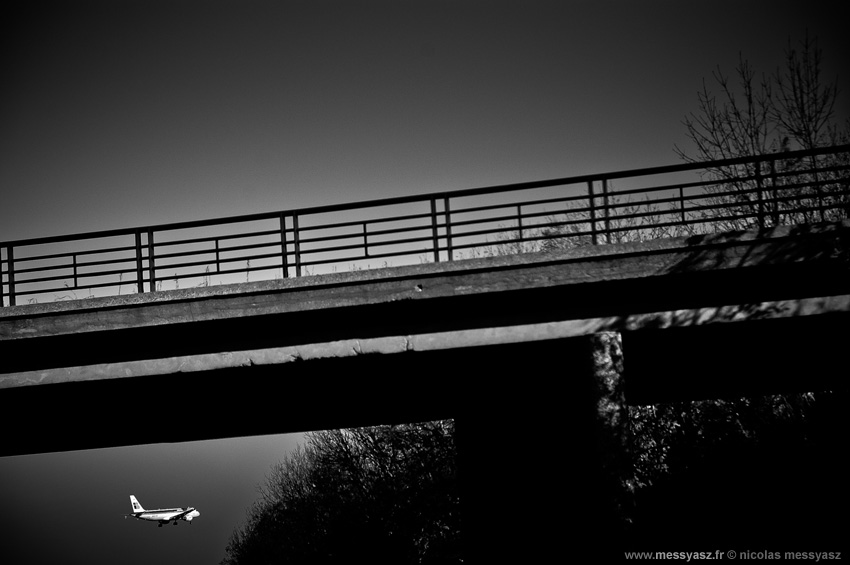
0;304;848;455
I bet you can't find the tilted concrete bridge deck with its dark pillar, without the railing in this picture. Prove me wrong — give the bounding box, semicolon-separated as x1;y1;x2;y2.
0;223;850;558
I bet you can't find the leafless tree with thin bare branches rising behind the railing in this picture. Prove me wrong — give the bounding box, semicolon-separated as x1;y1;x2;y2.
674;36;850;231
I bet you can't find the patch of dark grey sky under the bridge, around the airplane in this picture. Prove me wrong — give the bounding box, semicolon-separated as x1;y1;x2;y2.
0;432;303;565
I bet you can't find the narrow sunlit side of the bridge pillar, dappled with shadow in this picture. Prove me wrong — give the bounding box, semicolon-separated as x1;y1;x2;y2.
588;332;632;534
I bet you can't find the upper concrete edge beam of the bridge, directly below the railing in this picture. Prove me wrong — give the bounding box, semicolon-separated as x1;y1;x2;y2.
0;221;850;341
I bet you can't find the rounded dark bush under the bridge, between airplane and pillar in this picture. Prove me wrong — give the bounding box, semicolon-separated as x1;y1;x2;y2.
222;420;461;565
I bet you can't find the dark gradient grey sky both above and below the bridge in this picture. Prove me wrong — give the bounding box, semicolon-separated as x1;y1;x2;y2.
0;0;850;565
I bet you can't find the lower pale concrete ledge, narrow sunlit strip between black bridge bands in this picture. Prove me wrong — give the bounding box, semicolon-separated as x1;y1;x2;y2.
0;295;850;389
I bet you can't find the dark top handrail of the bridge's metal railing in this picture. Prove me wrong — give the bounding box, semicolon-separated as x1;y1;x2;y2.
0;144;850;247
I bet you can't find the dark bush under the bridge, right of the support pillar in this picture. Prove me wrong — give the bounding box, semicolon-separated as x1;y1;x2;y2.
630;392;848;551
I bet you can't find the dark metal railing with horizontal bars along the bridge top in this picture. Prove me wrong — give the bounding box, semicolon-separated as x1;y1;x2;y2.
0;145;850;306
